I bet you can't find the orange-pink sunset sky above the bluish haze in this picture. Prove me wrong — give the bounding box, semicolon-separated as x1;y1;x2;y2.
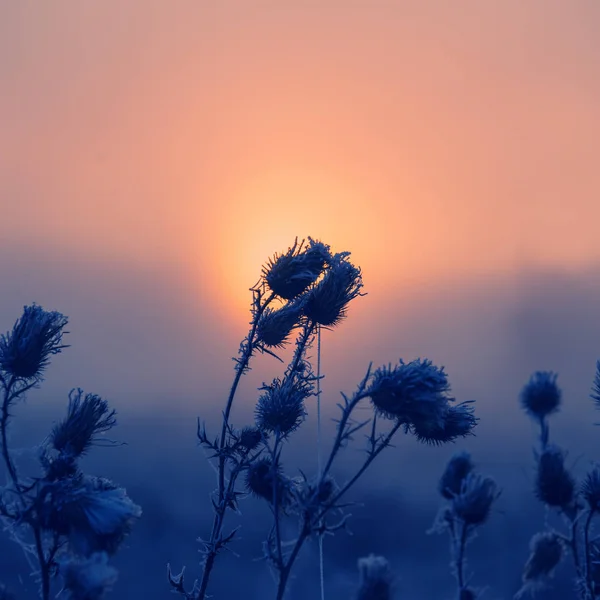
0;0;600;318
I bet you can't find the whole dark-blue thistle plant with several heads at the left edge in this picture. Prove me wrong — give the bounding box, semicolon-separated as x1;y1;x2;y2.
0;305;141;600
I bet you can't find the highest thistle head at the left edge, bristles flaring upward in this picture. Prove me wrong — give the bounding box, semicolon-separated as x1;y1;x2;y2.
0;304;68;380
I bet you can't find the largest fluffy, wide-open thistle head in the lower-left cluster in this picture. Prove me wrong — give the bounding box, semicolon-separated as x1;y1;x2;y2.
39;476;142;556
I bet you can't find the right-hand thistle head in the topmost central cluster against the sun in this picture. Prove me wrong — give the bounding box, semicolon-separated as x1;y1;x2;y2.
304;252;363;327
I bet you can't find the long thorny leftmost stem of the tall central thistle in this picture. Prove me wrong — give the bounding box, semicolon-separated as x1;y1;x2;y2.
196;292;275;600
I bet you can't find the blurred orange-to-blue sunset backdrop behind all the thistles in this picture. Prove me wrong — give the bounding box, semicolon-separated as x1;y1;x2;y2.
0;0;600;600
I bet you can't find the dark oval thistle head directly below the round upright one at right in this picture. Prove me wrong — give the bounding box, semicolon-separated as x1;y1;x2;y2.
535;446;575;508
